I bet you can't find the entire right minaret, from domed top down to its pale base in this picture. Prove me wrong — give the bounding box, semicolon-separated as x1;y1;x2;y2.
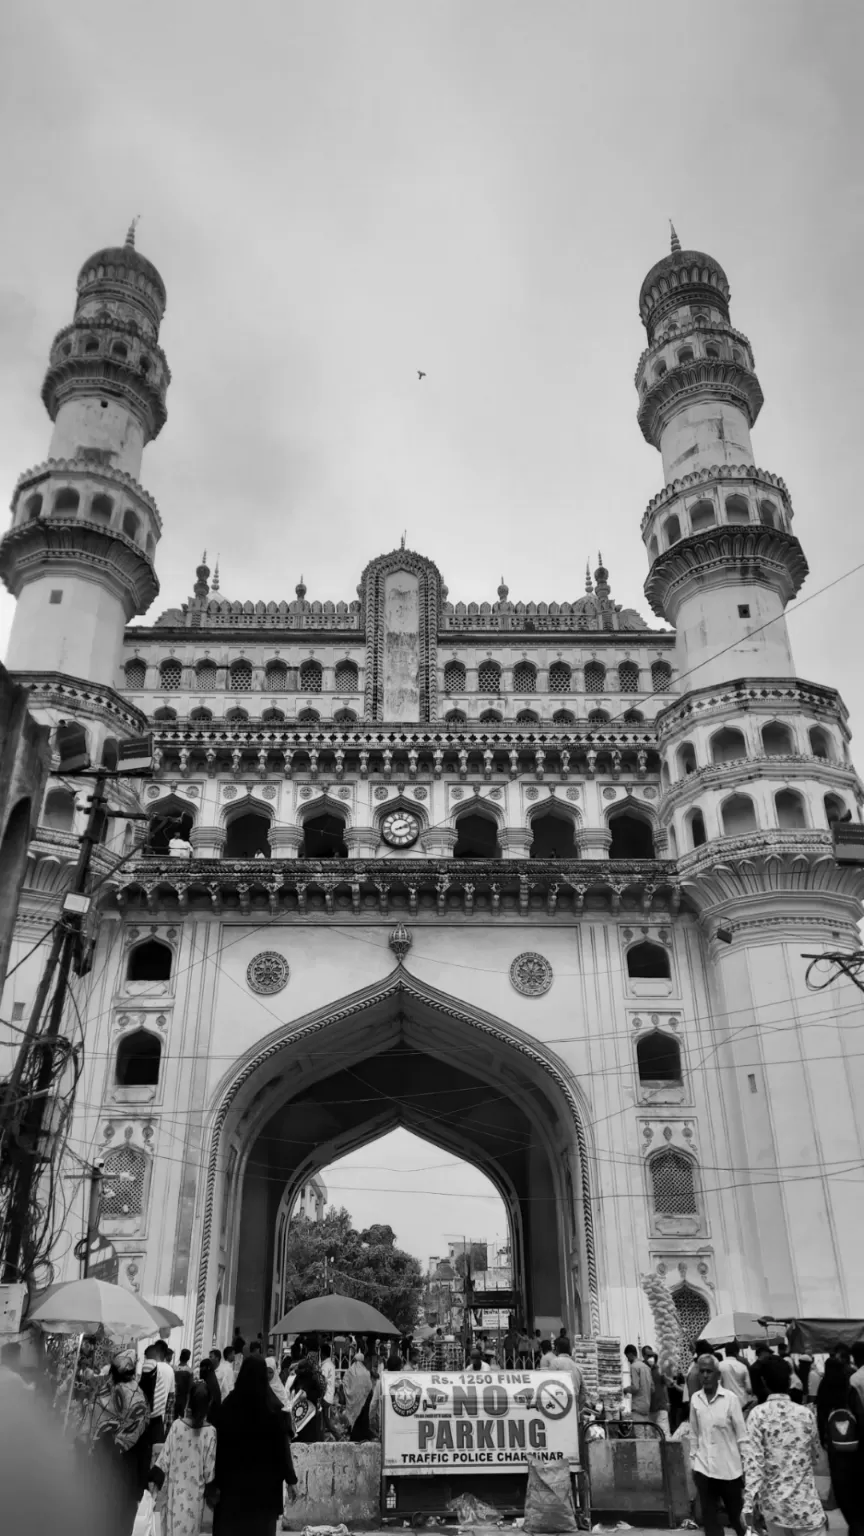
636;233;864;1316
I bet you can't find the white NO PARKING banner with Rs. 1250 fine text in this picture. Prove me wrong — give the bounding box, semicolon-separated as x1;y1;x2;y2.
381;1369;580;1478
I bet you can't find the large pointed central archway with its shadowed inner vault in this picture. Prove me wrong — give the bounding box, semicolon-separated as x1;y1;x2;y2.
195;966;600;1352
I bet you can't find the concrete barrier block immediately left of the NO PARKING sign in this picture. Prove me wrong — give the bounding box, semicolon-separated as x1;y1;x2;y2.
281;1441;381;1531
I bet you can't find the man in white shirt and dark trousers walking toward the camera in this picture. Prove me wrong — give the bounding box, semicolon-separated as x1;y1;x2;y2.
690;1355;747;1536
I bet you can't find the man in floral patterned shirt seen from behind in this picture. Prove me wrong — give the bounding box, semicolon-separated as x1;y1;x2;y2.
744;1355;827;1536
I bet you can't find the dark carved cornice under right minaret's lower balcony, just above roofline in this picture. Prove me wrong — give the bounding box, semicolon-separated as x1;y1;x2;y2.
644;524;809;617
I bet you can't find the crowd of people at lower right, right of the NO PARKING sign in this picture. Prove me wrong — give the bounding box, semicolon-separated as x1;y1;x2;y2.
624;1339;864;1536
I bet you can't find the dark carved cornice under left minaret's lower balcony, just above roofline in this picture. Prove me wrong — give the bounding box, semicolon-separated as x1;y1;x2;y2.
0;516;158;619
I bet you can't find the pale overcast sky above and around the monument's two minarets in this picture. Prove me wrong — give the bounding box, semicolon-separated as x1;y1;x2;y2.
0;0;864;1249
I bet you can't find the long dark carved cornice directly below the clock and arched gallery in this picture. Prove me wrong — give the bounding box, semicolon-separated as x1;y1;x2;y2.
111;857;680;922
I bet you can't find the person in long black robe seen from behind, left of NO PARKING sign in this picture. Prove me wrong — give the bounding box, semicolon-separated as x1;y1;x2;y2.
214;1353;297;1536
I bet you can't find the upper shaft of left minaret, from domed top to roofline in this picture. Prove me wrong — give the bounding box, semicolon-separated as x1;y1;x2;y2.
0;226;171;687
